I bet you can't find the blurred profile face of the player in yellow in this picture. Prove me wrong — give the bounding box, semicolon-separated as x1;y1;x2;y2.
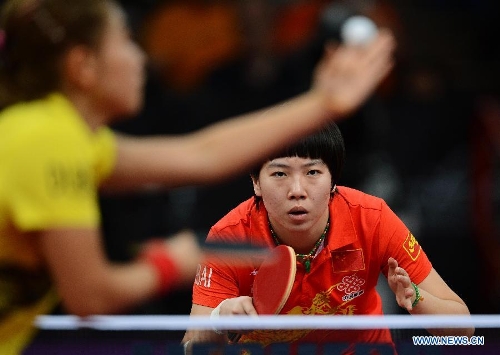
92;2;145;118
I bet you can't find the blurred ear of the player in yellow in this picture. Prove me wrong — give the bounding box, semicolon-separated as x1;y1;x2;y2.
63;45;98;89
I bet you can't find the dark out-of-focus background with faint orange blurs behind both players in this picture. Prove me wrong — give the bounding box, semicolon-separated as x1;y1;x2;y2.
97;0;500;322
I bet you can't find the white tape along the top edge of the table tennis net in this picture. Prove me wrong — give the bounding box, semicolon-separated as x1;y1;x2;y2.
35;315;500;330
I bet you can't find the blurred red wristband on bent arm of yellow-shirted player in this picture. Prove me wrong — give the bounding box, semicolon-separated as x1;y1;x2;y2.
140;239;182;293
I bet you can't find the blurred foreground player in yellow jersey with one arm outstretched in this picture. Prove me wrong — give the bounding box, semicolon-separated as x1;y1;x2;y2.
0;0;394;355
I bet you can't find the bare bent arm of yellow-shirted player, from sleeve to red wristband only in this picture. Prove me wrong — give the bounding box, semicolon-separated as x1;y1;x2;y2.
41;228;158;316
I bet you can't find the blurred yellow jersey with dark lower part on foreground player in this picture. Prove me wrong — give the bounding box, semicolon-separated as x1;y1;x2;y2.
0;93;116;355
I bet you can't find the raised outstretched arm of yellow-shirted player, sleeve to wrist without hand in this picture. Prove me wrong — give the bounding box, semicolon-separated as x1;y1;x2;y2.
105;91;332;189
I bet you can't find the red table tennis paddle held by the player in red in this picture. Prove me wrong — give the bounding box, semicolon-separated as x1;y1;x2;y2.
253;245;297;314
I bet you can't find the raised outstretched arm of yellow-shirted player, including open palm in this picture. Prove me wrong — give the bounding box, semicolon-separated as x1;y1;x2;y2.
105;31;395;192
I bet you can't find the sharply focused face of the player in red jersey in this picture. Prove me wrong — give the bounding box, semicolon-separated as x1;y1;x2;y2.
254;157;332;245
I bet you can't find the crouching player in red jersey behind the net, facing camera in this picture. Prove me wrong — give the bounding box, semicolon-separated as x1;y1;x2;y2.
184;123;474;354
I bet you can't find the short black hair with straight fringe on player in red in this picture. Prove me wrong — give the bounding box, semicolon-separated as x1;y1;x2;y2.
250;122;345;187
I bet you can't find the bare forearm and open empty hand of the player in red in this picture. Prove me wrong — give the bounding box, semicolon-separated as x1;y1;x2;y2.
387;258;474;336
